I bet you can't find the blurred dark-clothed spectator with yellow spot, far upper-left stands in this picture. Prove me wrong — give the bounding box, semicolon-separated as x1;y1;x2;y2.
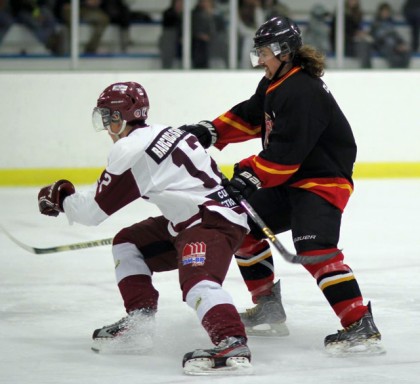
10;0;65;56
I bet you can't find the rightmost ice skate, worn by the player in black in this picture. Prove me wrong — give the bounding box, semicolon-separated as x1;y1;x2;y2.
324;302;385;356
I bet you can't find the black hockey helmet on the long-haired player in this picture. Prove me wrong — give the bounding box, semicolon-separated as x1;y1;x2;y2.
254;16;302;55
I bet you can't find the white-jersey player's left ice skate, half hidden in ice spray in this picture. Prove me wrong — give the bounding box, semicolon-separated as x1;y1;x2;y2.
91;308;156;354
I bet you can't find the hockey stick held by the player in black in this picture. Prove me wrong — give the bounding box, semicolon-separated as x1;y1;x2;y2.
239;198;341;264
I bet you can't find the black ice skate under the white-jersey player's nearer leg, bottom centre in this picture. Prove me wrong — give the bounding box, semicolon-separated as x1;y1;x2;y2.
182;336;253;375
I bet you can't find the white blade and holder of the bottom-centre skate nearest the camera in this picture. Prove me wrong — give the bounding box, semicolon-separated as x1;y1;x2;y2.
184;357;254;376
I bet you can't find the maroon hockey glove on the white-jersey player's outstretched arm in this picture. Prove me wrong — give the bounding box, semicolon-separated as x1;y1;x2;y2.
38;180;76;216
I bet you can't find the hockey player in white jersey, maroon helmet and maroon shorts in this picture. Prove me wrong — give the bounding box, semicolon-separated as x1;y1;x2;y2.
38;82;252;374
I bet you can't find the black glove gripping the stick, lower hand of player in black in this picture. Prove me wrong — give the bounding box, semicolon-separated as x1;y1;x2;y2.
222;164;261;203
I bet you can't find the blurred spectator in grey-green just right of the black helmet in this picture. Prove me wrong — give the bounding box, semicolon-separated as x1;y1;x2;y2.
304;4;331;54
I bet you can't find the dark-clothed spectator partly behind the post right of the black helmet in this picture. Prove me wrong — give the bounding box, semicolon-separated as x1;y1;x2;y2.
330;0;373;68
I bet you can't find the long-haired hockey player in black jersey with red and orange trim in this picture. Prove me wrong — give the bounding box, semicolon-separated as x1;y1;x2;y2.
184;17;384;354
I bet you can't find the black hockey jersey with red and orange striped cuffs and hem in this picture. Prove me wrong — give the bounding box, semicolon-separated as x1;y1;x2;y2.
213;67;356;210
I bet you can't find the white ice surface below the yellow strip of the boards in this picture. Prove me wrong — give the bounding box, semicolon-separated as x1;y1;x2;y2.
0;179;420;384
